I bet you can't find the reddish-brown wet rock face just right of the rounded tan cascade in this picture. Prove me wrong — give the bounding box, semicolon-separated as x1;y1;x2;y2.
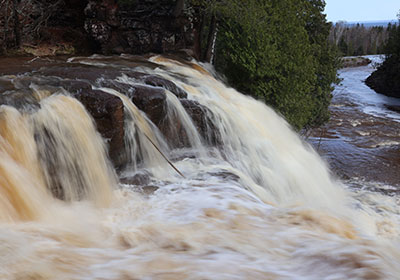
74;90;126;167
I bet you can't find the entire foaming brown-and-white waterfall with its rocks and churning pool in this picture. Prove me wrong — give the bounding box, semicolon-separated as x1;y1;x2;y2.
0;55;400;279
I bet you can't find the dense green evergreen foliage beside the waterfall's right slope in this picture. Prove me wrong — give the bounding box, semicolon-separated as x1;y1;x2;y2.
197;0;338;129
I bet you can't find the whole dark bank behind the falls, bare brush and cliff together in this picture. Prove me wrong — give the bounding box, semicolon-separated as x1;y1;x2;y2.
0;0;200;56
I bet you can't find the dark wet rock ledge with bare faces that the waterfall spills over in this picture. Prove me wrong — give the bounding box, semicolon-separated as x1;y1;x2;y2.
0;56;217;168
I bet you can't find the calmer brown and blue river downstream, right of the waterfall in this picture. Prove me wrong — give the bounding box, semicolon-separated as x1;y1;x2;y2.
308;56;400;192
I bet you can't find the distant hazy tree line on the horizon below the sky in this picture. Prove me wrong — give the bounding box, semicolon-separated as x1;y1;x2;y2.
329;22;396;56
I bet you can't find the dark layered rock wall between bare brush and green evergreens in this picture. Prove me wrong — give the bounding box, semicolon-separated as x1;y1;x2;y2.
85;0;197;54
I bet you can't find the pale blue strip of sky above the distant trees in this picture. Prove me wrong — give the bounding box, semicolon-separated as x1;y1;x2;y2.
325;0;400;22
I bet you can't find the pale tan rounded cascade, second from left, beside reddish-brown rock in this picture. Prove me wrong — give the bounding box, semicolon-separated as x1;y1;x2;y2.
32;95;116;204
